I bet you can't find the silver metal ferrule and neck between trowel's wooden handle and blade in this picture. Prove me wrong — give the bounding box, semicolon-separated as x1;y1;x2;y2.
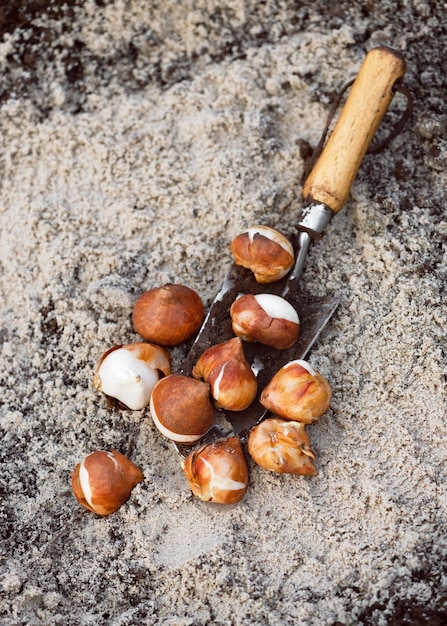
282;202;333;297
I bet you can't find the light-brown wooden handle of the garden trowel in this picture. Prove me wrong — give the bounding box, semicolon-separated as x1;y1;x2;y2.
303;47;406;212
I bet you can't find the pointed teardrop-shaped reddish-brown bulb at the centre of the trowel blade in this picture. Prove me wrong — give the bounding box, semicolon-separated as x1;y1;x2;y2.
192;337;258;411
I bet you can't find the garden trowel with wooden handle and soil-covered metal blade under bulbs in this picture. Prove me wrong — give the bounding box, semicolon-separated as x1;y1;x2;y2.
182;47;405;439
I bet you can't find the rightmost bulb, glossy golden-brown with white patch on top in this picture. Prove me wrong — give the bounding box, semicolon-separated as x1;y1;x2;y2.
260;360;332;424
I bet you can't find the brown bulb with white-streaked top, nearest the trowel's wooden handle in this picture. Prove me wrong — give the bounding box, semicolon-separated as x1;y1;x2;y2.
230;226;294;284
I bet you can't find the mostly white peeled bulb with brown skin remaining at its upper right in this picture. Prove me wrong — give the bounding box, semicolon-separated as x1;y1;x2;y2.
93;342;171;411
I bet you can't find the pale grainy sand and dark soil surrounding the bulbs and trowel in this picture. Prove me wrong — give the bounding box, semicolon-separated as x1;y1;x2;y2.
0;0;447;626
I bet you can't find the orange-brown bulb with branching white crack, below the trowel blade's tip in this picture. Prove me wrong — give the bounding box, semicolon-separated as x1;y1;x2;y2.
183;437;248;504
